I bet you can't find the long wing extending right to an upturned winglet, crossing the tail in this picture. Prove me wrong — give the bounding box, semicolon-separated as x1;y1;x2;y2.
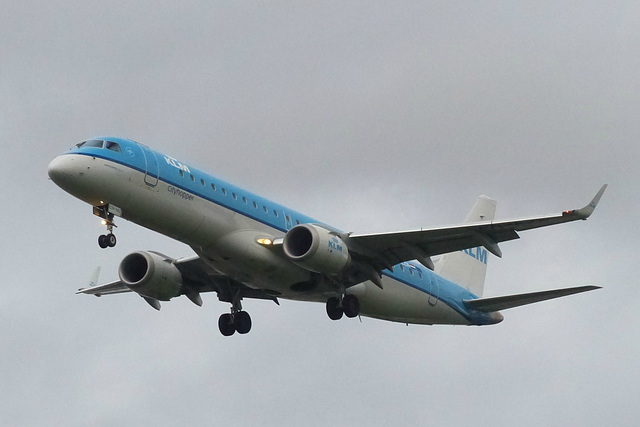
348;184;607;270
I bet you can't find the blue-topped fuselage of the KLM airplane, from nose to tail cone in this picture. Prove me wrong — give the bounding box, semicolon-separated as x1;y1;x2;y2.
49;137;502;325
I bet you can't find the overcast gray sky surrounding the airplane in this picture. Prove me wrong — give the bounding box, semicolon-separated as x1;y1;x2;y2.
0;0;640;426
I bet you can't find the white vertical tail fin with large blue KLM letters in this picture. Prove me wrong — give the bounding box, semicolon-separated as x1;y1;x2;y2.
435;196;496;297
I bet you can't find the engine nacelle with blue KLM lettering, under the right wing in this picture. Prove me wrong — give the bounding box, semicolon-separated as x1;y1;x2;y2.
282;224;351;275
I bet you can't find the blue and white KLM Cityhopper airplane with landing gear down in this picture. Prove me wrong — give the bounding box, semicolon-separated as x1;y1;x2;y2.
48;137;607;336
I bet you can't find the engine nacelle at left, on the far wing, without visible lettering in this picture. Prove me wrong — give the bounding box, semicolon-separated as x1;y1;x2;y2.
118;251;182;301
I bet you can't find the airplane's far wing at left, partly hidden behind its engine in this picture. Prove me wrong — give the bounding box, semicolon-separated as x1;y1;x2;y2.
76;255;278;310
